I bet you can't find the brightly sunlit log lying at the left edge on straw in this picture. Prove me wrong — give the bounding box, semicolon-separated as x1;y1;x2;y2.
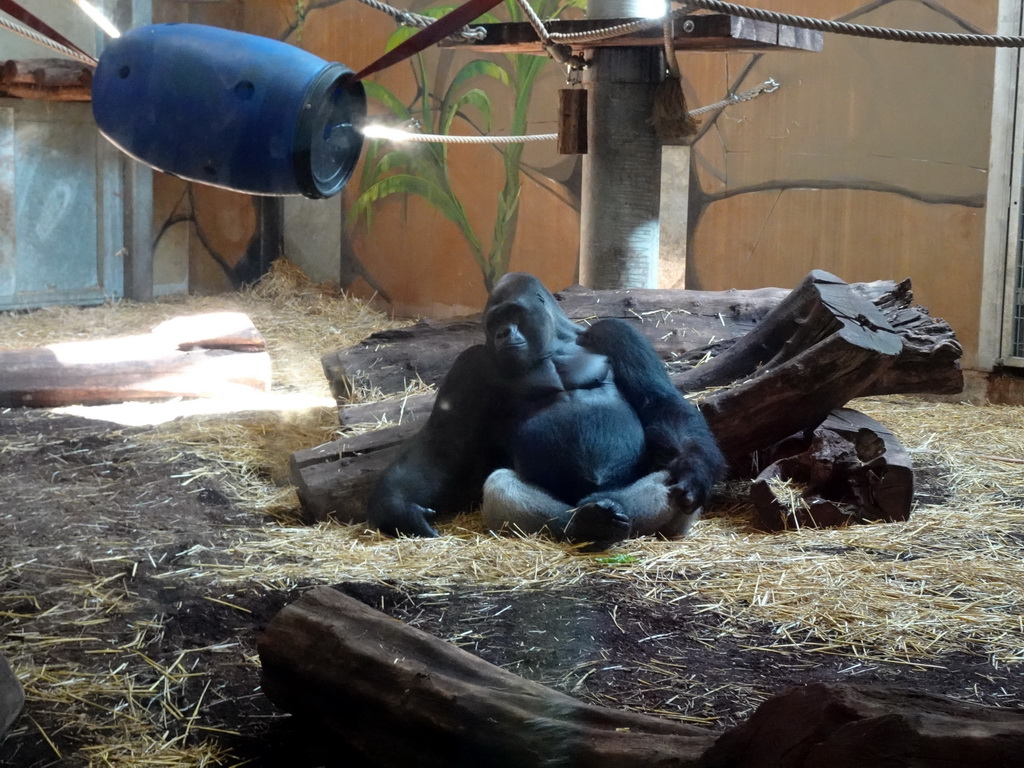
0;312;270;408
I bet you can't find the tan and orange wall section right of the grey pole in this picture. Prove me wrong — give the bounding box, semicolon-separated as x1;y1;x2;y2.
680;0;997;366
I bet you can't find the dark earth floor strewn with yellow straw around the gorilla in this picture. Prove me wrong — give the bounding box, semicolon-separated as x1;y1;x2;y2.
0;267;1024;766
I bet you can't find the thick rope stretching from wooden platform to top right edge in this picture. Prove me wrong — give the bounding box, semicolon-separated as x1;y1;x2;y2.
680;0;1024;48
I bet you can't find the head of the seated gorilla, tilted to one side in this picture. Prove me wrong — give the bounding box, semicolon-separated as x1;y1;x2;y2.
483;272;580;372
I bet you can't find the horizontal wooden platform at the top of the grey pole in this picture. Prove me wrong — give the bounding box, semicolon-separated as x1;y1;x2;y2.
438;13;823;55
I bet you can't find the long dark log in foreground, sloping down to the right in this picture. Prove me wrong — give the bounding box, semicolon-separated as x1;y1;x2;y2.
258;587;714;768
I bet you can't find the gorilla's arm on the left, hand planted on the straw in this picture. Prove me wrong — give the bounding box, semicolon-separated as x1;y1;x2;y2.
367;346;494;537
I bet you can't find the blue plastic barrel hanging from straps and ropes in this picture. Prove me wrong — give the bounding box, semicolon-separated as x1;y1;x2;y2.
92;24;367;198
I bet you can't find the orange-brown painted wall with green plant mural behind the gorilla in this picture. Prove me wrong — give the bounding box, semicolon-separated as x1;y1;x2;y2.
156;0;997;366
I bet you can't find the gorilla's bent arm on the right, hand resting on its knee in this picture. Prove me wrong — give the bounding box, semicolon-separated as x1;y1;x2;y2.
579;318;725;518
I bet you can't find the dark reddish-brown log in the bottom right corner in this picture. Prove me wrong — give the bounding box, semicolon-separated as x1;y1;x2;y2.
699;683;1024;768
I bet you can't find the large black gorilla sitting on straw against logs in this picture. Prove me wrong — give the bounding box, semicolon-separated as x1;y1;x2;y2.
367;272;725;549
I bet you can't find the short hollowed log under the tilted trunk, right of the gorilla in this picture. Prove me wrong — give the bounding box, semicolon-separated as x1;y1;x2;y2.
751;409;913;530
